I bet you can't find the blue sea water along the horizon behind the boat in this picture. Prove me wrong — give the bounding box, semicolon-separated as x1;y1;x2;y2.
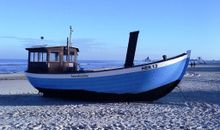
0;59;220;74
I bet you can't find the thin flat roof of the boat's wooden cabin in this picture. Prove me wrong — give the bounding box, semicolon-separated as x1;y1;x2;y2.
26;46;79;52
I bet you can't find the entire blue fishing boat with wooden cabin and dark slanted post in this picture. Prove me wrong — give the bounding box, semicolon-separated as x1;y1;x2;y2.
26;29;190;101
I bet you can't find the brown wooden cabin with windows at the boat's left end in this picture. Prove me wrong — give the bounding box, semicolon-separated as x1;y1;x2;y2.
26;46;79;73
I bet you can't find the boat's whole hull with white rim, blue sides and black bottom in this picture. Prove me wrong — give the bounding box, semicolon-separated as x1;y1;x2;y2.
27;53;189;100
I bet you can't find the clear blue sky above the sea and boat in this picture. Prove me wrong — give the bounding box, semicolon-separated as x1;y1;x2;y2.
0;0;220;60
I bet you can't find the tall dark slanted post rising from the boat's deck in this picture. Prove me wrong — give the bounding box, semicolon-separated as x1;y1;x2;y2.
124;31;139;68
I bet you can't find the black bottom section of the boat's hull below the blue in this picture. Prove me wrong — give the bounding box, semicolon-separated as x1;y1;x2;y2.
38;80;180;101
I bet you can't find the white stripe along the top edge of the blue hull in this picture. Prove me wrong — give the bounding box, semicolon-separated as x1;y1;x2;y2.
26;55;188;79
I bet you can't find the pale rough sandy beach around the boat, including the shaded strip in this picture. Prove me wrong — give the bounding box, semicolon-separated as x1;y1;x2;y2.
0;65;220;130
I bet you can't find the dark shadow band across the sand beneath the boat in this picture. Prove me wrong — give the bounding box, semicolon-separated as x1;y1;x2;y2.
0;91;220;106
